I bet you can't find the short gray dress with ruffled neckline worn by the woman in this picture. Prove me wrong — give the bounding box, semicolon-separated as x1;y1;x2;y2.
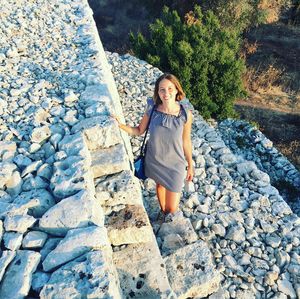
145;99;187;192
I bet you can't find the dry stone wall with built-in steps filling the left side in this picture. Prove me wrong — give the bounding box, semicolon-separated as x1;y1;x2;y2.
0;0;175;298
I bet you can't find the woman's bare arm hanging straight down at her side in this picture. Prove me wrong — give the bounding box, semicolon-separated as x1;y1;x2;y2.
182;110;194;181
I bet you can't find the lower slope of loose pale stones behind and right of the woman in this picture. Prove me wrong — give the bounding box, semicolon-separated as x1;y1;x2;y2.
107;52;300;299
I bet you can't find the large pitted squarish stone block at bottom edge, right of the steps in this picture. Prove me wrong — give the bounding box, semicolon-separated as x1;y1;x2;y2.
164;241;220;298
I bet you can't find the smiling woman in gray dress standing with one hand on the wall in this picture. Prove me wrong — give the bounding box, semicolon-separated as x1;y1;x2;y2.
113;74;194;218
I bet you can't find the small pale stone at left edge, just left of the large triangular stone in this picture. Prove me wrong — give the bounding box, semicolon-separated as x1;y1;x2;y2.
4;215;36;233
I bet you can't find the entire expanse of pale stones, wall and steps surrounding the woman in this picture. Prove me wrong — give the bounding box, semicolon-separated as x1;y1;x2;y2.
0;0;300;299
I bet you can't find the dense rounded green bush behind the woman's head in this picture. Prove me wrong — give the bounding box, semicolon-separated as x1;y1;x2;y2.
130;6;245;119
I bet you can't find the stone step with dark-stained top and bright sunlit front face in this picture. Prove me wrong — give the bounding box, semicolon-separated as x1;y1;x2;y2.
106;205;153;245
